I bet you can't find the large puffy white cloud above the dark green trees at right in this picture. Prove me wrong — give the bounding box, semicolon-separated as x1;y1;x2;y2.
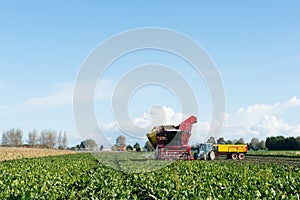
222;97;300;141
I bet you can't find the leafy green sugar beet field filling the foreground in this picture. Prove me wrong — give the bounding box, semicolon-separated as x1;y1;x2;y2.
0;152;300;199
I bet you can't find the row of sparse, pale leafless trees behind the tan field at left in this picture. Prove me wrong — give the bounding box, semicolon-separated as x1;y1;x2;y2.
1;128;68;149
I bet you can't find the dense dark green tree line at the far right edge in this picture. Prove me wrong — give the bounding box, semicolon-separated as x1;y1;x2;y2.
266;136;300;150
